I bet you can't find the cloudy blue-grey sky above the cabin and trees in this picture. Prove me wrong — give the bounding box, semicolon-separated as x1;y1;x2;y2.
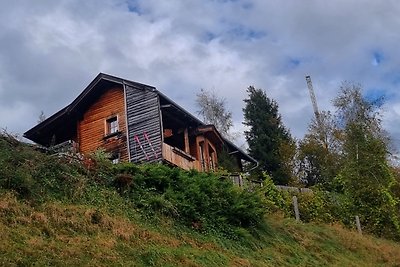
0;0;400;151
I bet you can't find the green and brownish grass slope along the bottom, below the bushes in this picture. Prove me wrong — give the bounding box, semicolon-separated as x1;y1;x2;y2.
0;191;400;266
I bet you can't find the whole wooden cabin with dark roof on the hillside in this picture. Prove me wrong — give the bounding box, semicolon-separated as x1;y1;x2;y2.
24;73;256;171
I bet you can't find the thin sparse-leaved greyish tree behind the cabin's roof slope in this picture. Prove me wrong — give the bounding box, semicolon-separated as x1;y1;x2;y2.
196;89;233;137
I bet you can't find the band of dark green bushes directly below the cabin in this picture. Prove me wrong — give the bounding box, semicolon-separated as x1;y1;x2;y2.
0;132;265;236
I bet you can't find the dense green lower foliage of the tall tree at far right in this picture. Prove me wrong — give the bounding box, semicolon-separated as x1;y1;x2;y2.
341;124;400;238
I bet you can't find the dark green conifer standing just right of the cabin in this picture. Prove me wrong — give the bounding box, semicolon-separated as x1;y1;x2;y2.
243;86;294;184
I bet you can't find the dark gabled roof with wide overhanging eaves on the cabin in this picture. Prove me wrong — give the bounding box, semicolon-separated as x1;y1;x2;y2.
24;73;257;163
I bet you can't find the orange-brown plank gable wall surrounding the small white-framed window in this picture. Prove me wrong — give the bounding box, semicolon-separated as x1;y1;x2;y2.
77;87;128;161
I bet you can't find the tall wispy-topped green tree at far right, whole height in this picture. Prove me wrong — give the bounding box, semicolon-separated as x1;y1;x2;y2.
333;83;400;238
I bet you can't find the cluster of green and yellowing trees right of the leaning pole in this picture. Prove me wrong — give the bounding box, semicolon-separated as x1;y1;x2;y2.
298;82;400;239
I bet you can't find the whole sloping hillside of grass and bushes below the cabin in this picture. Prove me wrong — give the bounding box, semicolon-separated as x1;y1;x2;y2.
0;134;400;266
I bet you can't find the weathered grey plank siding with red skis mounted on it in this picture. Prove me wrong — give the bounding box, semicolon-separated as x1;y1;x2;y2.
125;85;162;162
